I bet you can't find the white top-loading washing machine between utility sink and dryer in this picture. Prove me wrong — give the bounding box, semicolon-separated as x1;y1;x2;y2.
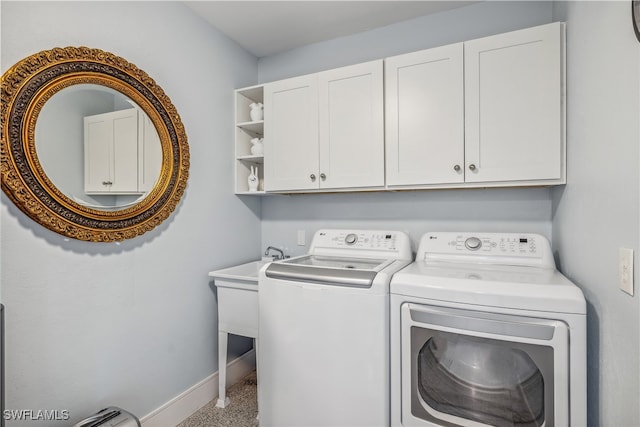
258;230;412;427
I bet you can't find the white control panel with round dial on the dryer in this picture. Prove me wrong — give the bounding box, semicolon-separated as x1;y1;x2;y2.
416;232;555;268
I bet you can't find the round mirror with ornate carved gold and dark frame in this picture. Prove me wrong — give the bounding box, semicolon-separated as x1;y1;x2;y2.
0;47;189;242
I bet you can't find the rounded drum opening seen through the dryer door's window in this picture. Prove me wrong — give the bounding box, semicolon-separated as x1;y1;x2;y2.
417;335;545;427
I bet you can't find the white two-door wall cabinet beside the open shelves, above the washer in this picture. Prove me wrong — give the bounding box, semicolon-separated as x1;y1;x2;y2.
264;60;384;191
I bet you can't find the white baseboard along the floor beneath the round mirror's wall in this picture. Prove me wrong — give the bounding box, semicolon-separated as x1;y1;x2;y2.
140;350;256;427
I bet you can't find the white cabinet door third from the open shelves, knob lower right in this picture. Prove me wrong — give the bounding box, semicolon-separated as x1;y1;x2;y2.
385;43;464;186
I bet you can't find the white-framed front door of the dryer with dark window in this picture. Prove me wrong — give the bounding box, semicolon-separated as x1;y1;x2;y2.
401;303;569;427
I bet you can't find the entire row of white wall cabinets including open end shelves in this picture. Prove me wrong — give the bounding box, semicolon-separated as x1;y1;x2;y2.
236;23;566;194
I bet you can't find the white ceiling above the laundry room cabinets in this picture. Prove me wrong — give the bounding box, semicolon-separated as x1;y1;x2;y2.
185;0;474;57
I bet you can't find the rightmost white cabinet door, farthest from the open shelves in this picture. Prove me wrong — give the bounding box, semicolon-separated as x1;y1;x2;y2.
464;23;565;183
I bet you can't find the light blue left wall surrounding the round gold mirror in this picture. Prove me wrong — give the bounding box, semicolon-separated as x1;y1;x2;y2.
0;1;260;426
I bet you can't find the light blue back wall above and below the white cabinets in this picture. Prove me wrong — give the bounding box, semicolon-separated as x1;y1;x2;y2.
259;2;553;254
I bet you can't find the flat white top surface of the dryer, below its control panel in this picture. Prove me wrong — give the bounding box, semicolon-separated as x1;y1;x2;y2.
390;260;586;314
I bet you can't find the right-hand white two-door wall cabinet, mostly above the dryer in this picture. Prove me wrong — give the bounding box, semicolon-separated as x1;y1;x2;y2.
385;23;566;188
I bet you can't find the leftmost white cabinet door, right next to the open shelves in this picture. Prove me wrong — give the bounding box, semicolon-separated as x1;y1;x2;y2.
264;75;320;191
